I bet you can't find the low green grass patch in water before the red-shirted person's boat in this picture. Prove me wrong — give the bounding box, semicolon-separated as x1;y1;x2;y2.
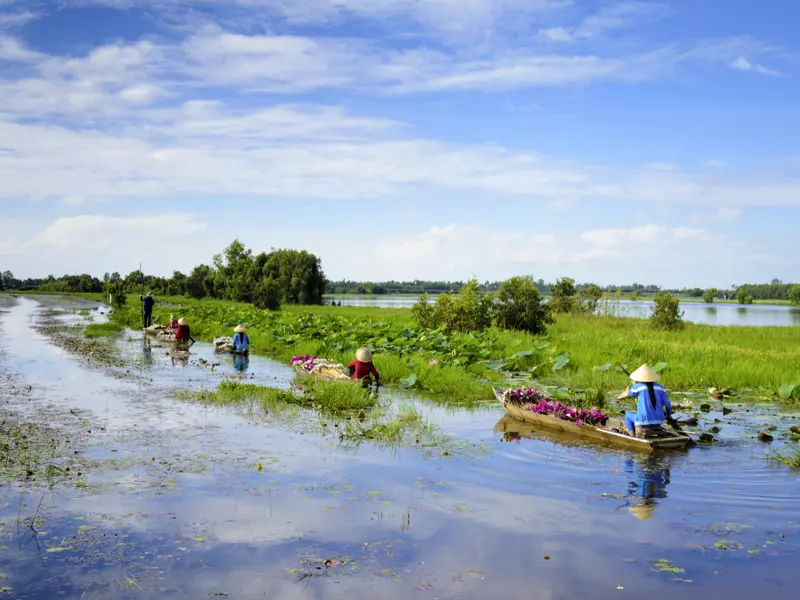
194;379;377;413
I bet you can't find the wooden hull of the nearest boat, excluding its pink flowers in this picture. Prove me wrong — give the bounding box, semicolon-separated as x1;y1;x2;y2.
494;387;691;452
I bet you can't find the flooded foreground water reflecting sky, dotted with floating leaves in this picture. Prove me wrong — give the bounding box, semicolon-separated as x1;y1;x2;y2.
0;299;800;600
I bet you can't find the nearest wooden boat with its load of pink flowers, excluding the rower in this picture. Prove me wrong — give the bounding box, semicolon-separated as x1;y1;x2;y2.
494;387;690;452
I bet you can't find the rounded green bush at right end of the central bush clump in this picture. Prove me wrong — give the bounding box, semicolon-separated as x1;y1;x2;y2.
494;276;553;335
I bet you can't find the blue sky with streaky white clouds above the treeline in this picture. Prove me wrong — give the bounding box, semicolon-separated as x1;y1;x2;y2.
0;0;800;287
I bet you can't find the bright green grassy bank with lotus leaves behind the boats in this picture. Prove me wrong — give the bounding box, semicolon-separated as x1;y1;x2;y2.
103;296;800;401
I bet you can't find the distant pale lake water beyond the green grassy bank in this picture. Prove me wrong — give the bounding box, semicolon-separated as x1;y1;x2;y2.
326;295;800;327
